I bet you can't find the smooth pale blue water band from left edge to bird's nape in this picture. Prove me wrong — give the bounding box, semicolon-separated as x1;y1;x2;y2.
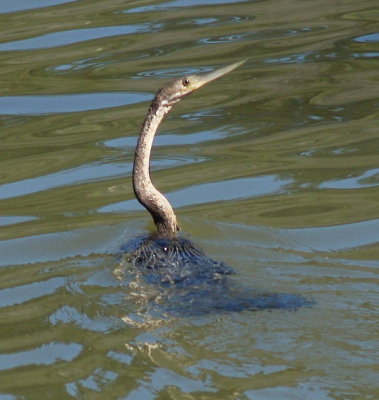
0;92;152;115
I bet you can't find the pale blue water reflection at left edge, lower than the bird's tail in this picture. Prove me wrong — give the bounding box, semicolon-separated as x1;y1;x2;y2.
0;342;83;371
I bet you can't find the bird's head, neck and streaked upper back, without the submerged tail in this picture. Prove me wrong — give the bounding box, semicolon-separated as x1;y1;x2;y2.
123;60;246;278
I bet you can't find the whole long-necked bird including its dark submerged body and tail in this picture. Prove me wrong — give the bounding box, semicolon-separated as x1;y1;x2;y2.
123;61;309;315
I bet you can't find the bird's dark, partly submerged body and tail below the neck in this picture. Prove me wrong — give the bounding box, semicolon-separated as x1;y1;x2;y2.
121;236;314;317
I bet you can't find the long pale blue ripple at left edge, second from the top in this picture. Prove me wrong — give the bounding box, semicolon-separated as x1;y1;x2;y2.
0;24;161;51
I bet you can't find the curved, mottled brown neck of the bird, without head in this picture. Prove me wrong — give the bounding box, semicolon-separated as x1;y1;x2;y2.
133;98;179;236
